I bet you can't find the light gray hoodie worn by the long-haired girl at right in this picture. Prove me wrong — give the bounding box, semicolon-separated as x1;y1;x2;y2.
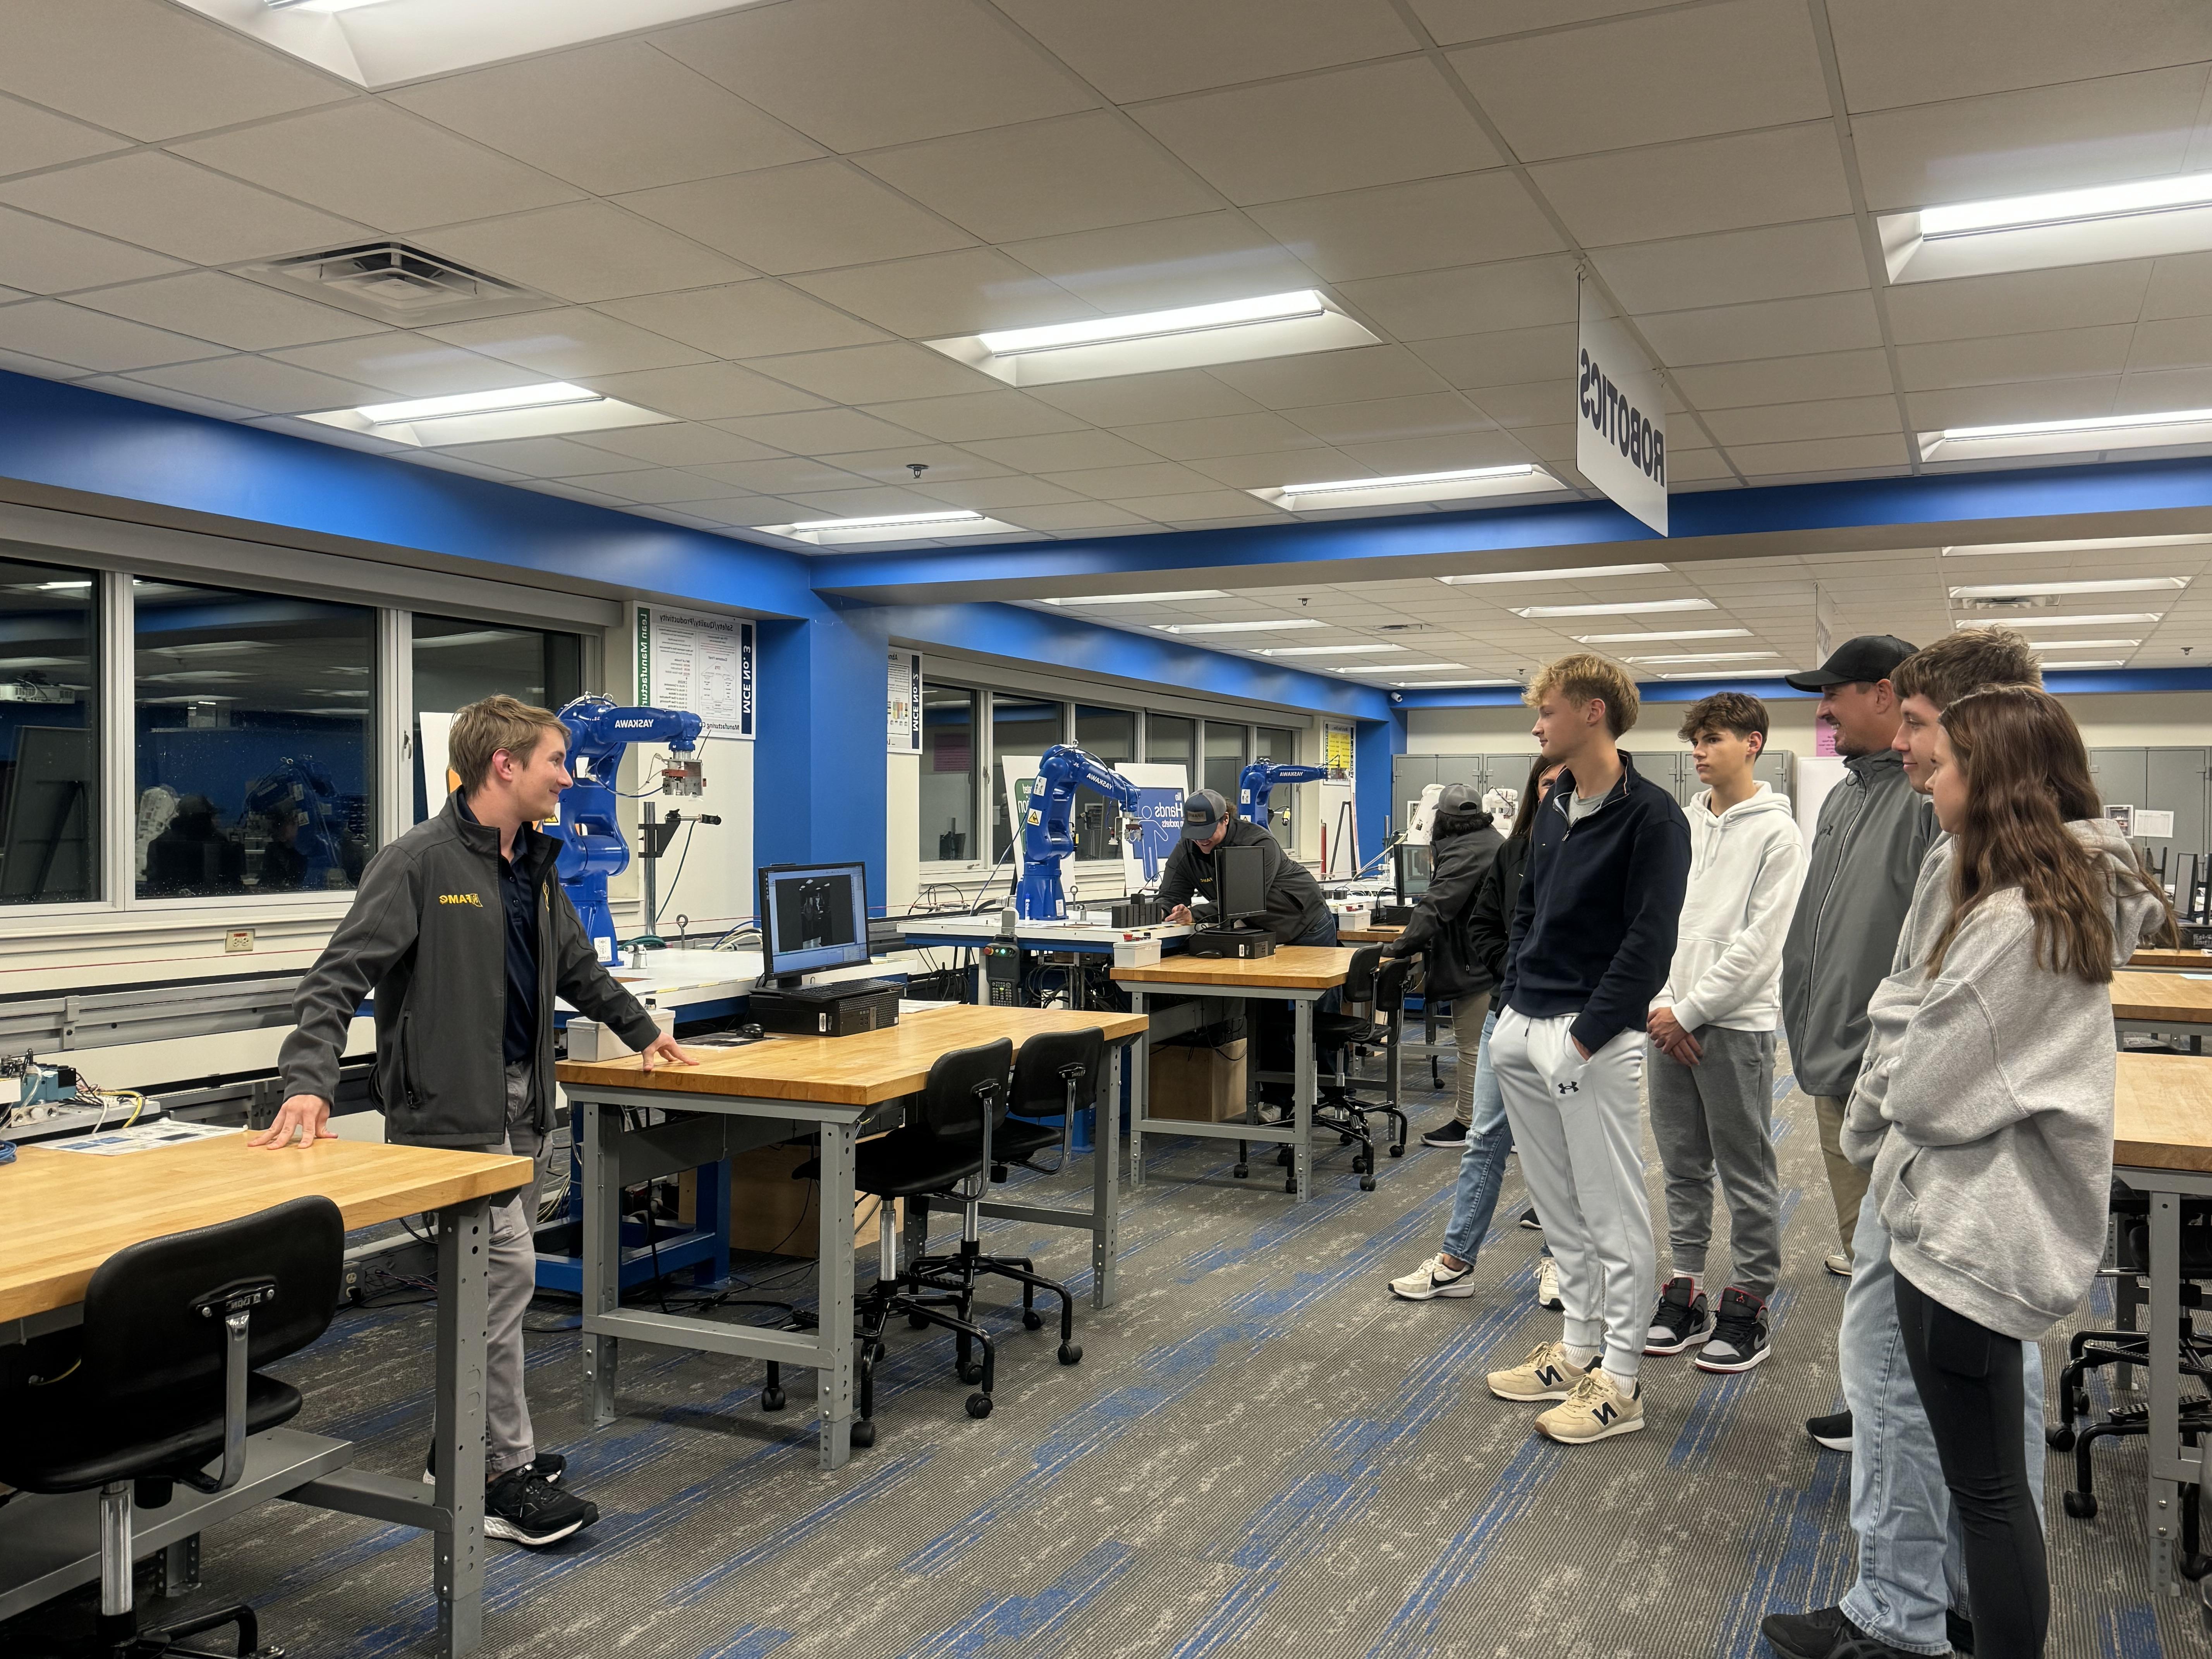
1843;818;2159;1340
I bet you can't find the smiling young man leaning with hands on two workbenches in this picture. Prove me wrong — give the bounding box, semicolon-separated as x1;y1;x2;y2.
252;697;690;1544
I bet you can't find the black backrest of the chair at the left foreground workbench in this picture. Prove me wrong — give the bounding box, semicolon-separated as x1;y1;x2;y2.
82;1197;345;1420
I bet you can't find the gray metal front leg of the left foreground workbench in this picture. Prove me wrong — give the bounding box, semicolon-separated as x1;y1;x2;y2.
431;1199;491;1659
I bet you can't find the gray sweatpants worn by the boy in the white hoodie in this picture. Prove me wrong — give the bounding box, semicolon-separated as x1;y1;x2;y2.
1644;1026;1783;1301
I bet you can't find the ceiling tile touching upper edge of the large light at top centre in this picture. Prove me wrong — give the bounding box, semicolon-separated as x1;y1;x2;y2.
1006;212;1316;316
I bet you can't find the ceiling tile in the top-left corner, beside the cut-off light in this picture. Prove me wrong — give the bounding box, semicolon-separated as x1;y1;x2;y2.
0;0;354;139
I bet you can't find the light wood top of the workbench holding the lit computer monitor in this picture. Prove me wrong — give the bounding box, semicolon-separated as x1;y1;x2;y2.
560;1004;1150;1106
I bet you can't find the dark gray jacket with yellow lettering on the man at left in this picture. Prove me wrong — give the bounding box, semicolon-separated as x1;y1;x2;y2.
276;796;659;1146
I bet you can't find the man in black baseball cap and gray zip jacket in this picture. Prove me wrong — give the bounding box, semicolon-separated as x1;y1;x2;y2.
1783;635;1936;1276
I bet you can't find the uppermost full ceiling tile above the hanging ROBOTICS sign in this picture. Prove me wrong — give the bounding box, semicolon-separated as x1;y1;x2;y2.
1451;0;1827;161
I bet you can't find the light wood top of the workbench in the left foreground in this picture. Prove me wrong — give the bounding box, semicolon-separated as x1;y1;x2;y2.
0;1135;531;1318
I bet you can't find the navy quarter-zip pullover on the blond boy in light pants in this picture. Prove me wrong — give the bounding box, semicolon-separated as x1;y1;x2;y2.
1500;752;1690;1055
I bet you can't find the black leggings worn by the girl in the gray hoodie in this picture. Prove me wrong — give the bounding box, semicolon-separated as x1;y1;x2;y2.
1896;1272;2051;1659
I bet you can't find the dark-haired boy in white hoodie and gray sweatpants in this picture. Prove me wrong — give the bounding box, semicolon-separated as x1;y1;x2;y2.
1644;692;1805;1371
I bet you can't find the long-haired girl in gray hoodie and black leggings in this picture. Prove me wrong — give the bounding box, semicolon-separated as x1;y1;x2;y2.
1847;686;2170;1659
